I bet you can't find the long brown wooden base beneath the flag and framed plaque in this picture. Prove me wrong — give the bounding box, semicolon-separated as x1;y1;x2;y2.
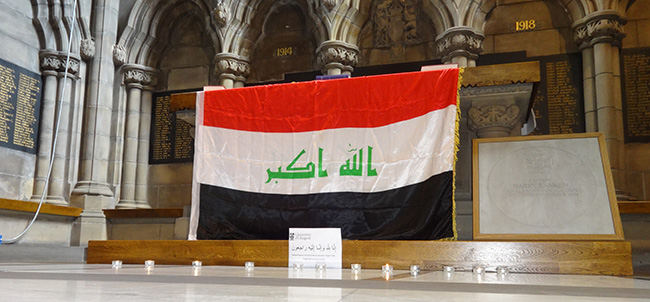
87;240;633;276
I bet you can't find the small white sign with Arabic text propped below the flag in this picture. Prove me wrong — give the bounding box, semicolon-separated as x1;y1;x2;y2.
289;228;343;269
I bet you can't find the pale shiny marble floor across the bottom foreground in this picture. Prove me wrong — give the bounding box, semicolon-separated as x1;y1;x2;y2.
0;263;650;302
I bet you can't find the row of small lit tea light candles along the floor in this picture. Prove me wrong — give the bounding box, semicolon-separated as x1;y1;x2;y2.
112;260;510;276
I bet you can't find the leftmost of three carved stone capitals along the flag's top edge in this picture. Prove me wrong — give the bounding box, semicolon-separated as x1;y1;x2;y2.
214;53;250;89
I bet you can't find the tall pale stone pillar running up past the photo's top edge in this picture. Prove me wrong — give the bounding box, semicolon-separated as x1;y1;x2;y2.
71;0;120;245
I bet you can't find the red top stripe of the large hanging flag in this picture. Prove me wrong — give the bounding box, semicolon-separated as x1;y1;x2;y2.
204;69;459;132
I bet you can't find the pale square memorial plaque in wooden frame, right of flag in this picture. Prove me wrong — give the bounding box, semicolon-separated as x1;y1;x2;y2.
472;133;623;240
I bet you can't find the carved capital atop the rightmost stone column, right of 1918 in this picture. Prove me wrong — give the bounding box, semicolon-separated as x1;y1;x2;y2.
573;11;627;49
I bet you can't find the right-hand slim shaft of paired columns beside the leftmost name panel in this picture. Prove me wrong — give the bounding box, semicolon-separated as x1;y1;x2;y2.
48;53;80;205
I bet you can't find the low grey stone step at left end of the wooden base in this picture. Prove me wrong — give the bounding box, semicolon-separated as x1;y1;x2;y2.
0;244;87;263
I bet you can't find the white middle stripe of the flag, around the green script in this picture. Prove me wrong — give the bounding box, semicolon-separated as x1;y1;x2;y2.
194;106;456;194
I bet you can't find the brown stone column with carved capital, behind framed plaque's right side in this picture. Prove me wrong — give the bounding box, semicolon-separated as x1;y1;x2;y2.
573;11;627;191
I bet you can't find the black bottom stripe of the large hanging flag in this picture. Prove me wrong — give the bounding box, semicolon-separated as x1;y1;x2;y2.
197;171;454;240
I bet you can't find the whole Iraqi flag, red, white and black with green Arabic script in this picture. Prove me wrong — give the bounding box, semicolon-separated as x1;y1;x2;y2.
189;69;460;240
